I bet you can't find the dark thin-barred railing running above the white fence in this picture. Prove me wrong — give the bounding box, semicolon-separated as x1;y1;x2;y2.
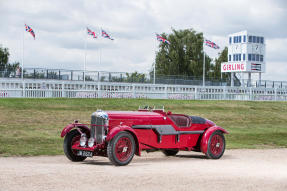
0;68;287;89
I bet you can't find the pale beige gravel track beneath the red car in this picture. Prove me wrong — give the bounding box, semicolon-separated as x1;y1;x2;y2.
0;149;287;191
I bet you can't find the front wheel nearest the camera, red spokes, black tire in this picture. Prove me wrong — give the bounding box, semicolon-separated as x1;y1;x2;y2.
107;131;136;166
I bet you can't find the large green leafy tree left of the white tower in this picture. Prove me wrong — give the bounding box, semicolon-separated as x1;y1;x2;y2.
152;29;211;77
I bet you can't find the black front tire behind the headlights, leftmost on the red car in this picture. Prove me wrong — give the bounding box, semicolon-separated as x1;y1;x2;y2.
63;129;87;162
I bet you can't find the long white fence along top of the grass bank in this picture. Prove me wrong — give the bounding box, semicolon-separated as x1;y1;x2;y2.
0;79;287;101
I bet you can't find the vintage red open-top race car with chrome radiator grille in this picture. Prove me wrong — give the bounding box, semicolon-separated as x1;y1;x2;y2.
61;109;228;166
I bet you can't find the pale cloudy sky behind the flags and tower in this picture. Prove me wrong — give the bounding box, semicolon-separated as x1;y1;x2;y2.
0;0;287;81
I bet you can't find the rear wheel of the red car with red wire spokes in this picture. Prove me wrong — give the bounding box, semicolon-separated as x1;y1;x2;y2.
205;131;225;159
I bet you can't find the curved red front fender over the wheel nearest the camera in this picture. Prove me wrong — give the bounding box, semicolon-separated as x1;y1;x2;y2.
106;126;141;156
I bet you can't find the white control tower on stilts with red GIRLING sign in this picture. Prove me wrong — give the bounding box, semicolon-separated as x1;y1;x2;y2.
221;31;266;85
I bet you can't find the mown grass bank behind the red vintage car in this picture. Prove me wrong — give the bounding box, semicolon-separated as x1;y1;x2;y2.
0;99;287;156
